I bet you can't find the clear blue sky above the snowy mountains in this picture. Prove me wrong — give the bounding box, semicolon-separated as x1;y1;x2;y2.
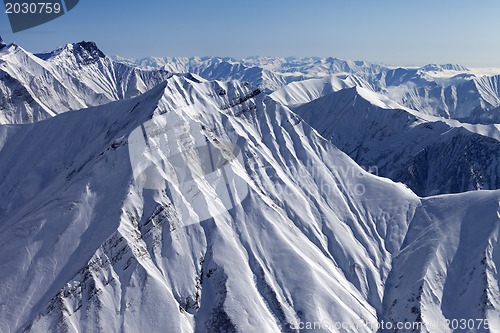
0;0;500;68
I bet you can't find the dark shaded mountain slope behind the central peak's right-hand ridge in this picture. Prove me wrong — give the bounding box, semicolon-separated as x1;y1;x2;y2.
295;87;500;196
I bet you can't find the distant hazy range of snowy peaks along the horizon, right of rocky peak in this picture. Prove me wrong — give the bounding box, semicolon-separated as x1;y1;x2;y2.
117;57;500;124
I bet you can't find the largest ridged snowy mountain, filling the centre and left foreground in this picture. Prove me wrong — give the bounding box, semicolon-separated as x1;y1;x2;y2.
0;76;419;332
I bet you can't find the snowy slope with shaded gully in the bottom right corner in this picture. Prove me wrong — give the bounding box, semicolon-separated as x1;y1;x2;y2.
384;191;500;332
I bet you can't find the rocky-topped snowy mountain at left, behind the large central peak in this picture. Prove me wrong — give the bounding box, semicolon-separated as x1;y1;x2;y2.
0;38;171;124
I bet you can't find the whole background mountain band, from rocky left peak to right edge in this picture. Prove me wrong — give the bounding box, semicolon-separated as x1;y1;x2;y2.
0;34;500;124
